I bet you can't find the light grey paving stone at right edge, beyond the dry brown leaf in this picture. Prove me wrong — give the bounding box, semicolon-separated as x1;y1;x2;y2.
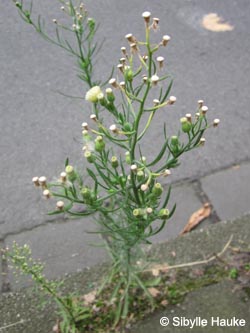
201;163;250;220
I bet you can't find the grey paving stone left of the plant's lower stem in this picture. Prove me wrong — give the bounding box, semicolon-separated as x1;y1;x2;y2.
6;220;108;290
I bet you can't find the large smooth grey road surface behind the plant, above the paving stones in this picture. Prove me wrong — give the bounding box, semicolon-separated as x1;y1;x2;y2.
0;0;250;238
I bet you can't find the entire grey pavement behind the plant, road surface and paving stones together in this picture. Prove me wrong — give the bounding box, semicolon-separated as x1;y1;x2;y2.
0;0;250;291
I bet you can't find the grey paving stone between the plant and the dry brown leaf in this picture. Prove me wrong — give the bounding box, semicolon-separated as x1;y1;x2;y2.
151;183;212;243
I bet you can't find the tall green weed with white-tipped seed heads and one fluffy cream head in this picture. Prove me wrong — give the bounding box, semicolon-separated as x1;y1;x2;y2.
8;0;219;332
